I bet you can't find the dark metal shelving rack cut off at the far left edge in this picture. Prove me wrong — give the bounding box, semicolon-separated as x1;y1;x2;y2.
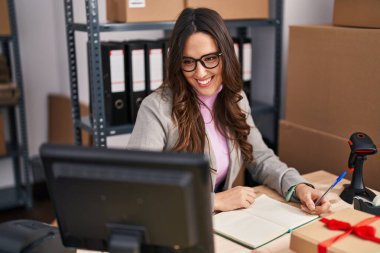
0;0;32;209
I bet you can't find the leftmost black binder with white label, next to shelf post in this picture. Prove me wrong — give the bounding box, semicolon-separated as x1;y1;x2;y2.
101;42;129;126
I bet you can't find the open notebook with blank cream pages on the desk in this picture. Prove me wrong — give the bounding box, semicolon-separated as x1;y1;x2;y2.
213;195;319;249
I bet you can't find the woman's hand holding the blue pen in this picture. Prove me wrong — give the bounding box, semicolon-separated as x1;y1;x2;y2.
296;184;331;214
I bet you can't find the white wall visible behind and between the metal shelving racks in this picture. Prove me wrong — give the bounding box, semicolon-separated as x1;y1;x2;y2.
0;0;333;187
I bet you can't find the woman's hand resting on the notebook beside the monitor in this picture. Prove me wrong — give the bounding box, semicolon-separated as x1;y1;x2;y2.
214;186;256;212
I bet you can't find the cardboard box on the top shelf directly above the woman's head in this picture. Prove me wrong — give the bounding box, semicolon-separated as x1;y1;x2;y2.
185;0;269;19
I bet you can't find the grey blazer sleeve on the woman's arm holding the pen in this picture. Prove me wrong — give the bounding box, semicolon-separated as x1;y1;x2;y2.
240;93;308;197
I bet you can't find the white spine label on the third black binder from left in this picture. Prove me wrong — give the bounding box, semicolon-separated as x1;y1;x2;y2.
149;49;163;91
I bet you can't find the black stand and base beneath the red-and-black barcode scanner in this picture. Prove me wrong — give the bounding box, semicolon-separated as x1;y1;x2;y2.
340;155;376;204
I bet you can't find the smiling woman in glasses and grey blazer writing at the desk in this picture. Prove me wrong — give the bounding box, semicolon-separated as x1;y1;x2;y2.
128;8;330;214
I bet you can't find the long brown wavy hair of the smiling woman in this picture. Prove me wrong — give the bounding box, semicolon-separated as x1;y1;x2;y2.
162;8;253;164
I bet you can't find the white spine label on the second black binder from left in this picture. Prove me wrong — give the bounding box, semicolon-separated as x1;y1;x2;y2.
132;49;145;92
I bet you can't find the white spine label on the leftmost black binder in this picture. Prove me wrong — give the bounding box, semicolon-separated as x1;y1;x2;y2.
110;50;125;93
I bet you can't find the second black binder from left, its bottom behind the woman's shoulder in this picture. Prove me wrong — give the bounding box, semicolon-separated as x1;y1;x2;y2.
124;40;147;124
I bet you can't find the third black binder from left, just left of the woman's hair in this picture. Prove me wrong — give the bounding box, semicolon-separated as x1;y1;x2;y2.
145;40;165;95
